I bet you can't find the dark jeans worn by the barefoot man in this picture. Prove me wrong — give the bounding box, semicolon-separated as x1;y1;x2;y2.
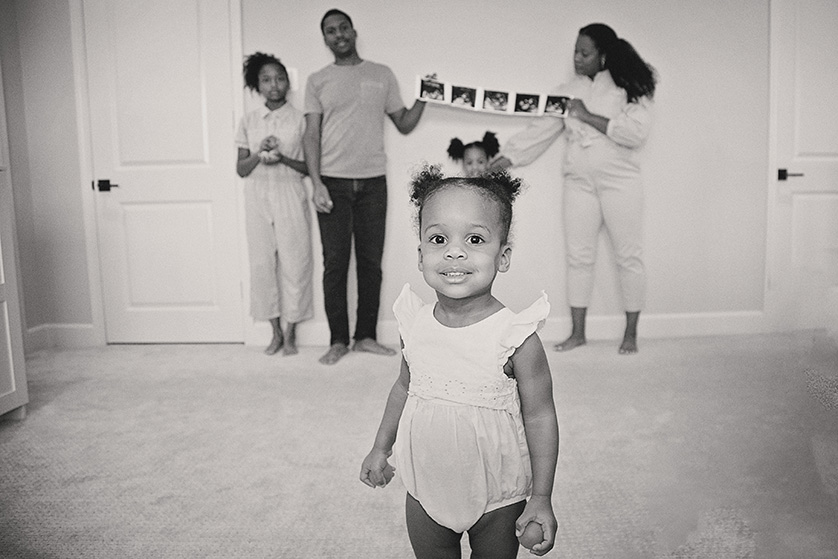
317;176;387;345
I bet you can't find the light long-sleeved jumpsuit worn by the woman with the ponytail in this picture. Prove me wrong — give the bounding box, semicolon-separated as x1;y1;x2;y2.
500;70;652;312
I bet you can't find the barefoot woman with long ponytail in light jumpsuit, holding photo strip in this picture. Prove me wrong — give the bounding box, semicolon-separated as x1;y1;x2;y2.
492;23;656;353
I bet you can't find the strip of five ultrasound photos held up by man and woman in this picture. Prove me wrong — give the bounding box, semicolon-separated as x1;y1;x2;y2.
416;75;573;117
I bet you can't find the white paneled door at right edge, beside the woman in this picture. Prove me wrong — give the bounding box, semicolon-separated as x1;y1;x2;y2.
766;0;838;328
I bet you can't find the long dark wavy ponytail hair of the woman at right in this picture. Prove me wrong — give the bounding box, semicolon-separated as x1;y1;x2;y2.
579;23;657;103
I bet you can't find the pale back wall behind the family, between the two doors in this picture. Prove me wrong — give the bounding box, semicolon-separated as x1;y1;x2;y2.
242;0;768;342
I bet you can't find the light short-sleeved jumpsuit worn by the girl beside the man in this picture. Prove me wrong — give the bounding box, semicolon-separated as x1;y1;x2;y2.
236;103;314;323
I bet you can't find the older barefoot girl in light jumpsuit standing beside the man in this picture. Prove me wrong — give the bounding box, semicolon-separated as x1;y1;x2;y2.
236;52;314;355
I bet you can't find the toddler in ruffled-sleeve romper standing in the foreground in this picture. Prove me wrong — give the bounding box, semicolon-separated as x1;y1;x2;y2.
360;167;559;559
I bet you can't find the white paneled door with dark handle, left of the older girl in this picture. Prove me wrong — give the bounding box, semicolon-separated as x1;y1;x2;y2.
83;0;244;343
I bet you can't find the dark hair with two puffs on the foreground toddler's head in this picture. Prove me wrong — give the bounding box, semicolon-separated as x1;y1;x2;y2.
410;164;524;242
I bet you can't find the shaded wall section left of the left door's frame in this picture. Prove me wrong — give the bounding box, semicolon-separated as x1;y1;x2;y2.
0;0;92;350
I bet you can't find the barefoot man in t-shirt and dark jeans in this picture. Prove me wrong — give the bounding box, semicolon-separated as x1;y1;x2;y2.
303;10;425;365
